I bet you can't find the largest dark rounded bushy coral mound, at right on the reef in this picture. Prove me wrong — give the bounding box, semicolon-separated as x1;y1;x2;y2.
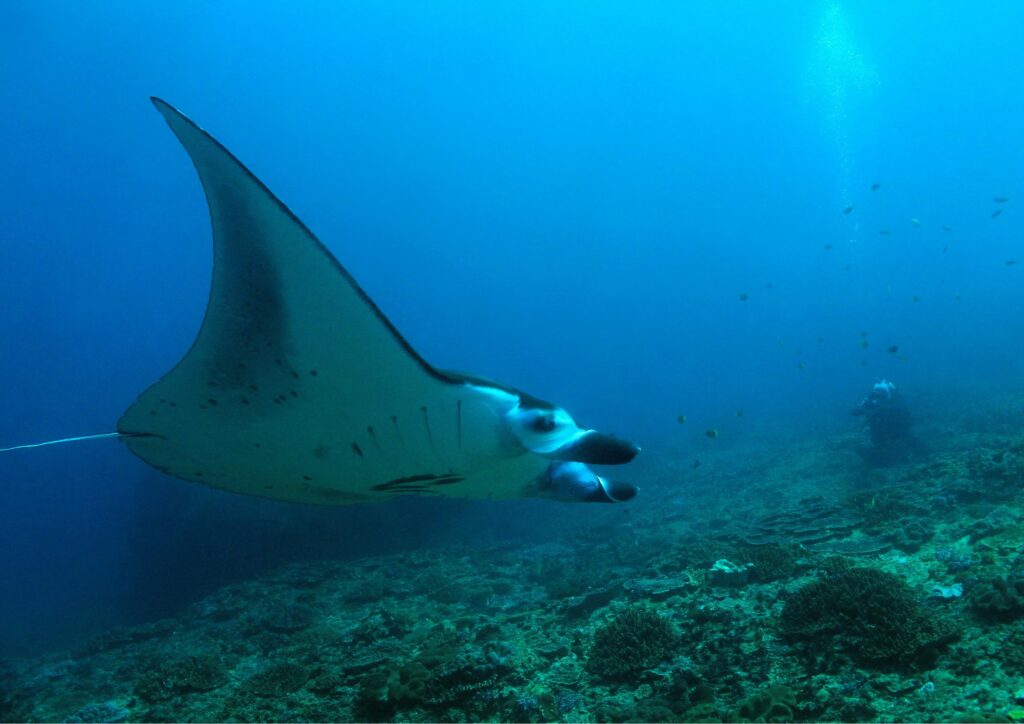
781;568;958;666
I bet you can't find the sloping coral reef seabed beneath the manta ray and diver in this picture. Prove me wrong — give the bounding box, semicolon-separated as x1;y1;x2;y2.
6;399;1024;722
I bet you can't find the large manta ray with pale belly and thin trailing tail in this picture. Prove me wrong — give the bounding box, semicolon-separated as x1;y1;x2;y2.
5;97;639;505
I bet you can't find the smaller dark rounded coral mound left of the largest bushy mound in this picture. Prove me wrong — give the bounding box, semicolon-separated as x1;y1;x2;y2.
587;606;678;680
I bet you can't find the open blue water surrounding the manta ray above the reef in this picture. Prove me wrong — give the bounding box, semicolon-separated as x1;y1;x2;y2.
0;0;1024;651
